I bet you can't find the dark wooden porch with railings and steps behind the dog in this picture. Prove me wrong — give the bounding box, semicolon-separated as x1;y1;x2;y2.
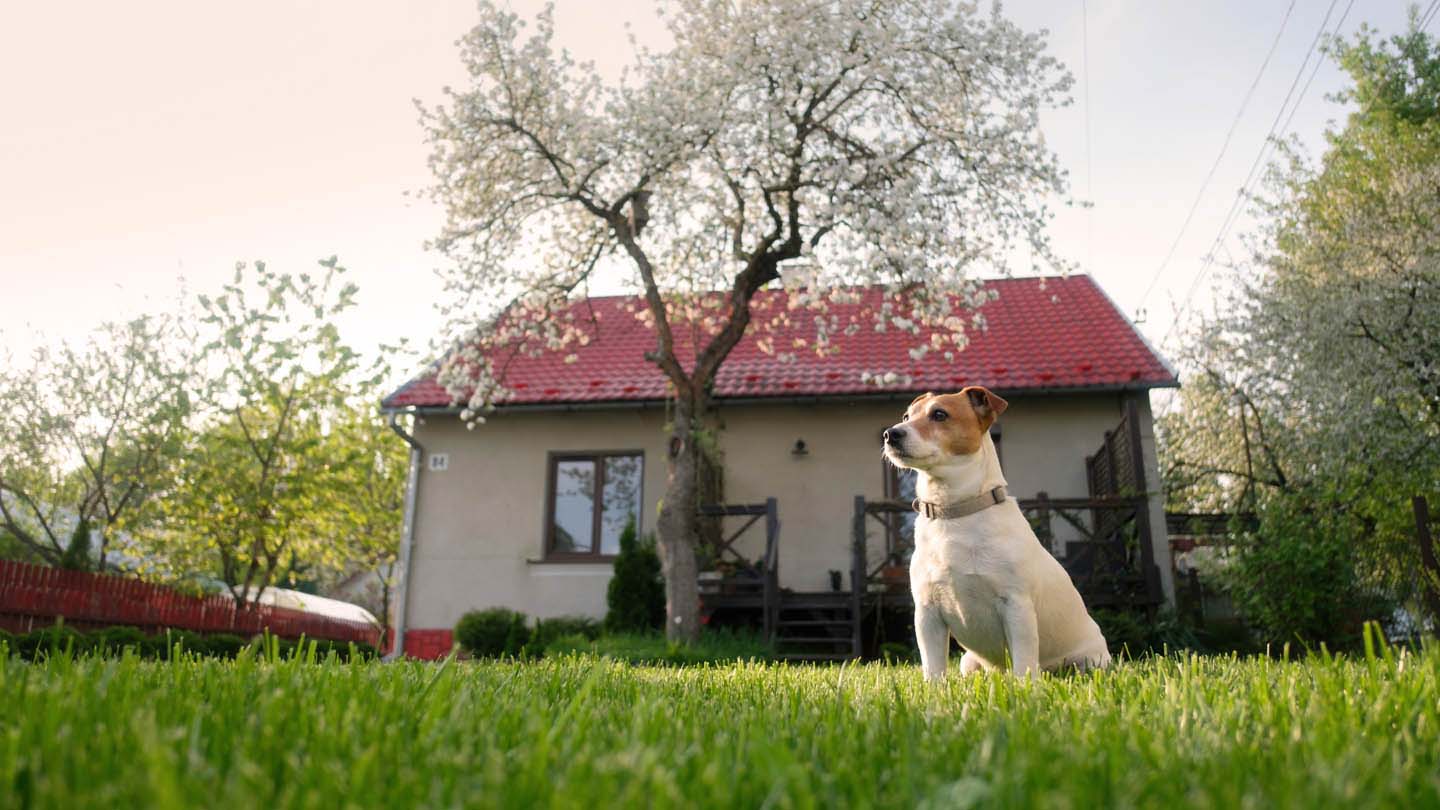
700;401;1164;660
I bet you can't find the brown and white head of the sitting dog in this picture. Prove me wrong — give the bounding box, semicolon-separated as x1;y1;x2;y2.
881;385;1009;470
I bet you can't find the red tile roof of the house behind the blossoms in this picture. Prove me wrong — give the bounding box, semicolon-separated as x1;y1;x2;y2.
383;275;1178;409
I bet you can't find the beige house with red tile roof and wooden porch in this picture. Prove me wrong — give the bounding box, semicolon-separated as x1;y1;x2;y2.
383;275;1178;657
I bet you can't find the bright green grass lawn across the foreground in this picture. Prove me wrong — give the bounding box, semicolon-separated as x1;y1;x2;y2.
0;639;1440;810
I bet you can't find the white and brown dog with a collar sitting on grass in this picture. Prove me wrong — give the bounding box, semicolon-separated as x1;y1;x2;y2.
883;385;1110;680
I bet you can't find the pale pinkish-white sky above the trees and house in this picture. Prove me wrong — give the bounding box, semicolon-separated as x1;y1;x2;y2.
0;0;1408;389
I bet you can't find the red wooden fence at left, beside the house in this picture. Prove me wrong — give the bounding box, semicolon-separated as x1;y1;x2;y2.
0;559;380;644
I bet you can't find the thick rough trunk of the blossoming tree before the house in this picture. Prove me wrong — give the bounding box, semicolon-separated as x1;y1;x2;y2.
658;399;700;641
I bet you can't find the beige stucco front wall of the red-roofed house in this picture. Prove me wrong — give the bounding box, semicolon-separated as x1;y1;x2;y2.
406;393;1168;628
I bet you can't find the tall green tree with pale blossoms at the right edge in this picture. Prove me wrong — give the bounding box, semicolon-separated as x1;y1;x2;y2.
1161;14;1440;633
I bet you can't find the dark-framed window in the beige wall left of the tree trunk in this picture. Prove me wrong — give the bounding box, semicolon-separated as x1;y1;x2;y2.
544;453;645;561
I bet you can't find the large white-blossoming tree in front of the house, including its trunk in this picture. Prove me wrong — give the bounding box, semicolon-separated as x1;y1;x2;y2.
422;0;1070;638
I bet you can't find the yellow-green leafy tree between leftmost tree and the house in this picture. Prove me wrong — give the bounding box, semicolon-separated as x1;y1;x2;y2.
145;258;377;602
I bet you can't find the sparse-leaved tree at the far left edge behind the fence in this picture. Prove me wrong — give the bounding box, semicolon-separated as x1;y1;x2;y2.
0;316;194;568
